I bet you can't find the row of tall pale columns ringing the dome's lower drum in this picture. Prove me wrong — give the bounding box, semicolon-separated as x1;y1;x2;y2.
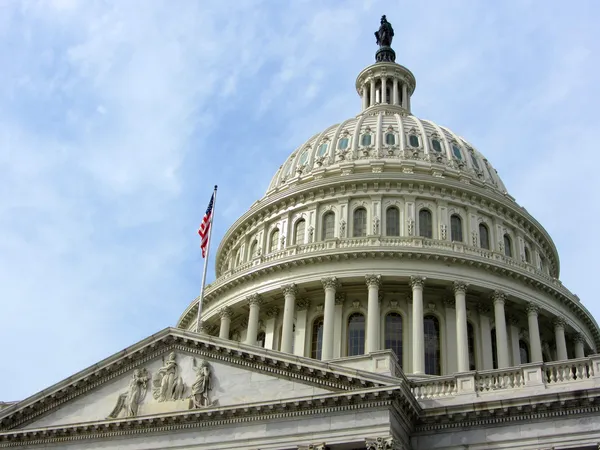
219;274;585;375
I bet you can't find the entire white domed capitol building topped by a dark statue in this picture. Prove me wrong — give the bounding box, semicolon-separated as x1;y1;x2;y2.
0;16;600;450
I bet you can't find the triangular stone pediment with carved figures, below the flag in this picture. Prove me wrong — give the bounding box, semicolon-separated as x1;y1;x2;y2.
0;328;393;430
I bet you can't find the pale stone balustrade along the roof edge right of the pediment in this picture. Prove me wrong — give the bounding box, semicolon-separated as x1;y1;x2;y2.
410;355;600;400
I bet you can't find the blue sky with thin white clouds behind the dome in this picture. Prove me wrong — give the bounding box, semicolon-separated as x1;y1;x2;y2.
0;0;600;401
